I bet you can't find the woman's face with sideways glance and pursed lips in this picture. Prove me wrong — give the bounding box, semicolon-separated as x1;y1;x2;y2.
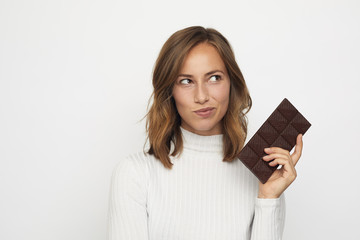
172;43;230;136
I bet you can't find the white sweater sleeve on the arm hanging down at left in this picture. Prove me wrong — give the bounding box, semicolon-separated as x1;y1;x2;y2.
107;156;148;240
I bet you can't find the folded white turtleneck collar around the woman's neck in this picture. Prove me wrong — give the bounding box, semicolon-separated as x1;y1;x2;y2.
180;126;223;152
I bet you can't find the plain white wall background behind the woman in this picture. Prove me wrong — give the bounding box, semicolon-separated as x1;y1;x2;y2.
0;0;360;240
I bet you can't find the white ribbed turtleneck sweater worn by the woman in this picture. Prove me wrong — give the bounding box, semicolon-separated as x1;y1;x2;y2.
108;127;285;240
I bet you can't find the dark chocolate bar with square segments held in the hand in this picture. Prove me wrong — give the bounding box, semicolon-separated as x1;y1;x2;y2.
238;98;311;183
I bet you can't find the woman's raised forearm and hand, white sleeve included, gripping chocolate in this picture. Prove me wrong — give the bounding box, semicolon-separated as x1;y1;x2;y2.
251;134;303;240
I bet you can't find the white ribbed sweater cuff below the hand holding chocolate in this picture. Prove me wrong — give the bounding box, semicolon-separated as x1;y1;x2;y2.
251;193;286;240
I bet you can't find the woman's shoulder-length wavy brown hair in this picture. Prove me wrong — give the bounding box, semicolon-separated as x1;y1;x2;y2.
144;26;252;169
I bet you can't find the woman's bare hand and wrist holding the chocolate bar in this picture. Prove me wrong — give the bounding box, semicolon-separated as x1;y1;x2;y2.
258;134;303;198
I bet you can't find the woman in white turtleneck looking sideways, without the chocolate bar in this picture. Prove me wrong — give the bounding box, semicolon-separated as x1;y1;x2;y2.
108;26;302;240
